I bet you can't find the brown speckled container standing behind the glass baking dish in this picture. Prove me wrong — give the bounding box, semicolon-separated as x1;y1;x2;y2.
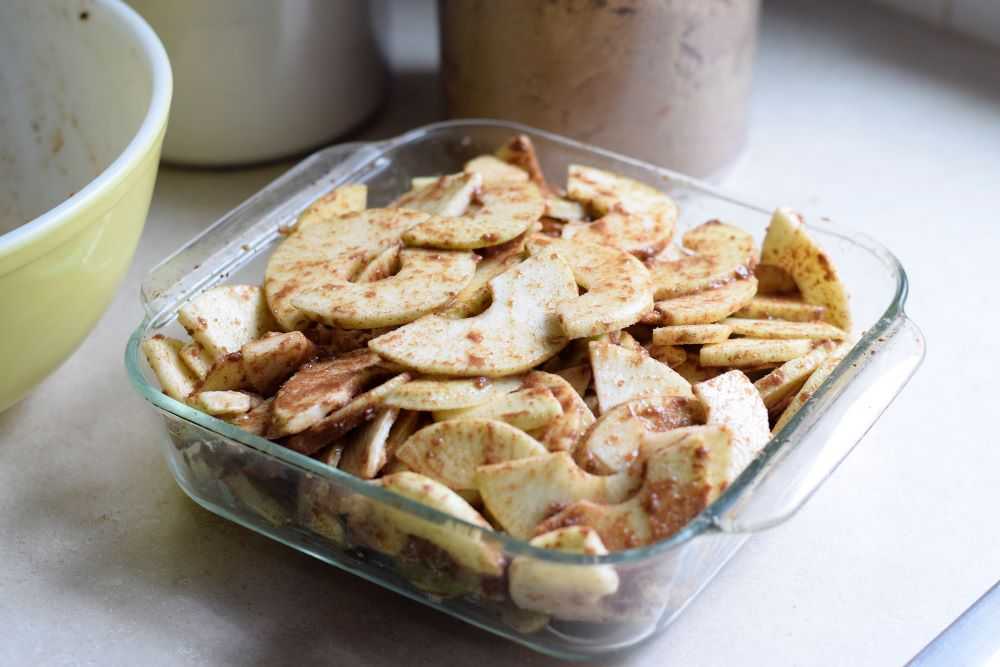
440;0;760;176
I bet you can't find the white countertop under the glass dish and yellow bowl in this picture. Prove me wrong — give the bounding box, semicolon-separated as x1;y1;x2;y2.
0;2;1000;666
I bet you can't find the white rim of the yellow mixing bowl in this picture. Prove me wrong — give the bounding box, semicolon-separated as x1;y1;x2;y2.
0;0;173;256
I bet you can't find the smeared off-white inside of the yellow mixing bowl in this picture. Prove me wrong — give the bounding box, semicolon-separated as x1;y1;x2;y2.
0;0;153;236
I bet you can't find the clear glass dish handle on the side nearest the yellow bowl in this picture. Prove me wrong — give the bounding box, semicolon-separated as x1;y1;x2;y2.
141;142;377;327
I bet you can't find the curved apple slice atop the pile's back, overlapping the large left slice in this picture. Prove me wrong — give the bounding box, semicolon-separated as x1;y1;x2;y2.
403;181;545;250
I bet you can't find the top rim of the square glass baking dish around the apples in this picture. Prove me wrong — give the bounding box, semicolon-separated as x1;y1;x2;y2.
124;119;909;565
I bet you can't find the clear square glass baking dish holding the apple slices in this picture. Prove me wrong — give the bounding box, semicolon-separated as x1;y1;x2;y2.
125;120;924;659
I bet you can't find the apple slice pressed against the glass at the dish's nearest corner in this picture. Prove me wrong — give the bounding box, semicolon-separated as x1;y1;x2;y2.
507;526;618;623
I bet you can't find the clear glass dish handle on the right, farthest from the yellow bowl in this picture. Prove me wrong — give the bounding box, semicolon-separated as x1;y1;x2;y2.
714;314;925;533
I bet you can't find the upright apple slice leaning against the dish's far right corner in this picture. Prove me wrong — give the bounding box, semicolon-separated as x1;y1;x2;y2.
761;208;851;332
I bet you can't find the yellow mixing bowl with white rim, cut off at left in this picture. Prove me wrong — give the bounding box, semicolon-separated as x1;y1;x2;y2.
0;0;172;411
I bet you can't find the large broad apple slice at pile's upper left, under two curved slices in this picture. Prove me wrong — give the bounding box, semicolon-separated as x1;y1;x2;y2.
264;209;430;331
